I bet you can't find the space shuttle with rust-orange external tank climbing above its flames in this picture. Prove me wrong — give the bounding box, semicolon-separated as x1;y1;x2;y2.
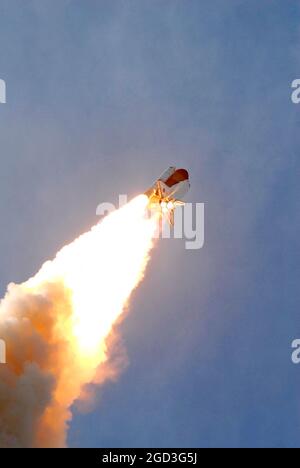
145;166;190;225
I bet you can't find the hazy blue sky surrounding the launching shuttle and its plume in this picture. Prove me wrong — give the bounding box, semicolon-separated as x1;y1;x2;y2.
0;0;300;447
